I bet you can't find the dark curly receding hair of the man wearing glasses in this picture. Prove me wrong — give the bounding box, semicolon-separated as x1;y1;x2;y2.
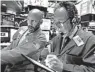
55;2;78;22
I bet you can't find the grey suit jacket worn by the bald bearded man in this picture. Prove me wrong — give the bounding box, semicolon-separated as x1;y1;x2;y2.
1;26;46;72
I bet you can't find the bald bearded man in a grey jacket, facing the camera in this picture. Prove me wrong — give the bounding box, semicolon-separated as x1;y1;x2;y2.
1;9;46;72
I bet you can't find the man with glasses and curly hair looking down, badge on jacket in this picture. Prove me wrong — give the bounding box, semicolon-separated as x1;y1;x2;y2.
45;2;95;72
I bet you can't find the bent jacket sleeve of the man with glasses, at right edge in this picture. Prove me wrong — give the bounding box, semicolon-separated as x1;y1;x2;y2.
63;36;95;72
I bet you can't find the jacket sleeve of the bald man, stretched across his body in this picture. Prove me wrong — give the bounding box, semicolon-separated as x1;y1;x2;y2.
1;34;46;64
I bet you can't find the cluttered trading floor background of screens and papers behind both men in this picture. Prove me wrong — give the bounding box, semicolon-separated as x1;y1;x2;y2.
0;0;95;72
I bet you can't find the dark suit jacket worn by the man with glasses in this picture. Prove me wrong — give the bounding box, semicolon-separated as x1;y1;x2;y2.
51;30;95;72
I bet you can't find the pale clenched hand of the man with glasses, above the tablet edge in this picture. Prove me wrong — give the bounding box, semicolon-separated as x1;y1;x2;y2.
45;54;63;72
